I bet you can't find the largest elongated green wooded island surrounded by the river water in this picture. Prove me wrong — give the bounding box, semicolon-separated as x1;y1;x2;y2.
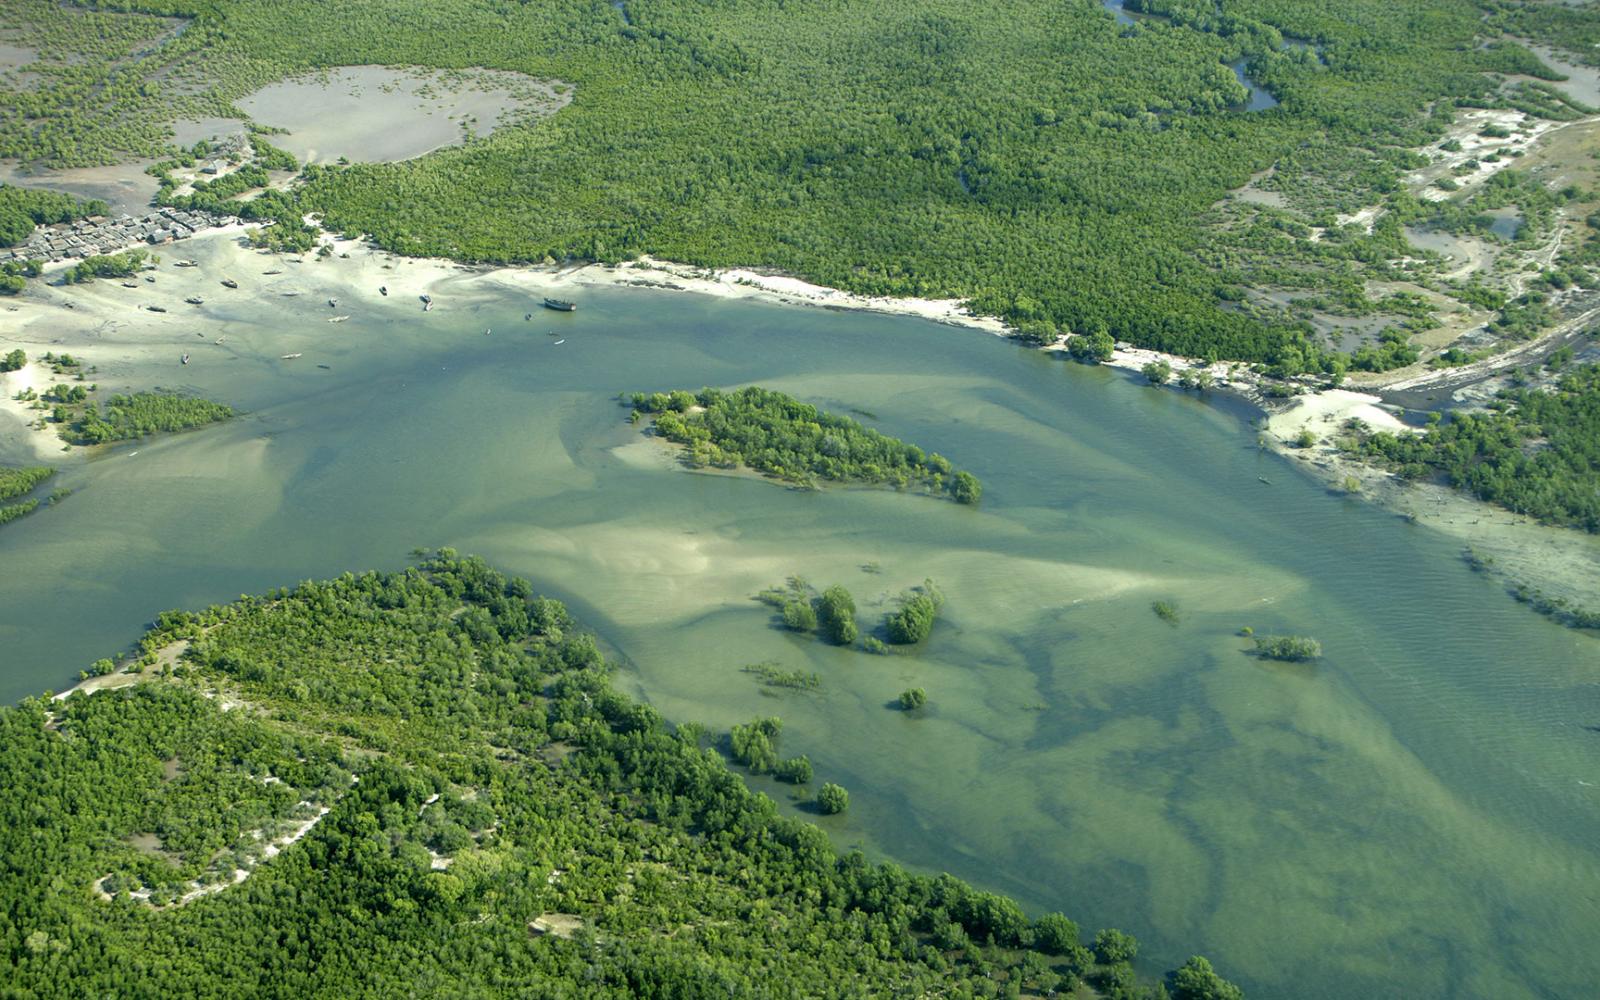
632;386;982;504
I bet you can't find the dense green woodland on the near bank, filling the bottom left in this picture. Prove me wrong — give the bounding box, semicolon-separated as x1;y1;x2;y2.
0;552;1235;998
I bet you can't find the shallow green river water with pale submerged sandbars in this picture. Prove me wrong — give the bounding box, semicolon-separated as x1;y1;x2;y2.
0;260;1600;1000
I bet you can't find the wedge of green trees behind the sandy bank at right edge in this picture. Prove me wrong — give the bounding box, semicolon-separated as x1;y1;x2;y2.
1346;365;1600;531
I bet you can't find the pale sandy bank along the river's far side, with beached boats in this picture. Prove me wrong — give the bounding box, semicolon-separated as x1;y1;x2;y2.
0;226;1600;620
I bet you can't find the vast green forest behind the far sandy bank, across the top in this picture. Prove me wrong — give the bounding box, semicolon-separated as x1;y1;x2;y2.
0;0;1600;371
